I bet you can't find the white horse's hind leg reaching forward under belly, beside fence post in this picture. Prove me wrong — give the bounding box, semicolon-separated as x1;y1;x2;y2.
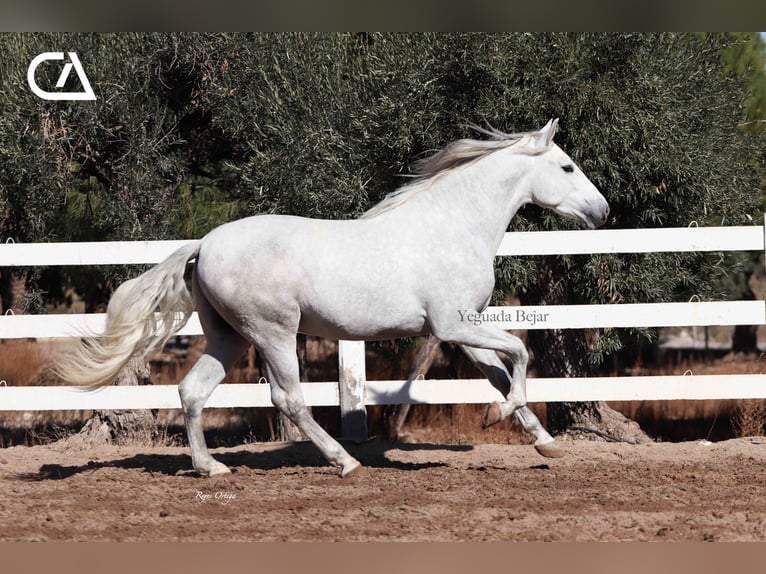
261;340;361;477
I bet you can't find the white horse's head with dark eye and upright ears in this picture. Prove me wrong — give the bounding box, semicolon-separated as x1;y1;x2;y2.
527;119;609;229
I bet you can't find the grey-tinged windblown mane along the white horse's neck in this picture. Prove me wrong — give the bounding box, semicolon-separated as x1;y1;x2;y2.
360;124;533;219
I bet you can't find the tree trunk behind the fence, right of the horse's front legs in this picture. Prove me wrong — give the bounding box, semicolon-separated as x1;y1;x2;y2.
521;257;649;443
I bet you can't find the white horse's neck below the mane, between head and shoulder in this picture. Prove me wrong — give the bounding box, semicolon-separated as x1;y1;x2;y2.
398;153;529;257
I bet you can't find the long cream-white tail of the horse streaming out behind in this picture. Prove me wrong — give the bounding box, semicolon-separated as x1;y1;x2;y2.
54;241;200;389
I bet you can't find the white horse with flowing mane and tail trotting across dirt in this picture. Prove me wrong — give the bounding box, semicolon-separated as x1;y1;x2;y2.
59;120;609;476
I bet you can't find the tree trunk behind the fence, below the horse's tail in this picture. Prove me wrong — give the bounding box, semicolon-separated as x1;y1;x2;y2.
73;357;157;446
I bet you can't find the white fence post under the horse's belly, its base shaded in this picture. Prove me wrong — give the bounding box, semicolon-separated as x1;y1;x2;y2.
338;341;367;441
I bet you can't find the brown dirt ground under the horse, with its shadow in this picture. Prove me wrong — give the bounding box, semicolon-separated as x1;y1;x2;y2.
0;438;766;541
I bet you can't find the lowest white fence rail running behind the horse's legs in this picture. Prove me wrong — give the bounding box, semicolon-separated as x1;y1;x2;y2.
0;375;766;414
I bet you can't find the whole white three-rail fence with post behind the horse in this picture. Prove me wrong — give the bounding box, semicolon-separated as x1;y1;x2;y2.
0;226;766;436
